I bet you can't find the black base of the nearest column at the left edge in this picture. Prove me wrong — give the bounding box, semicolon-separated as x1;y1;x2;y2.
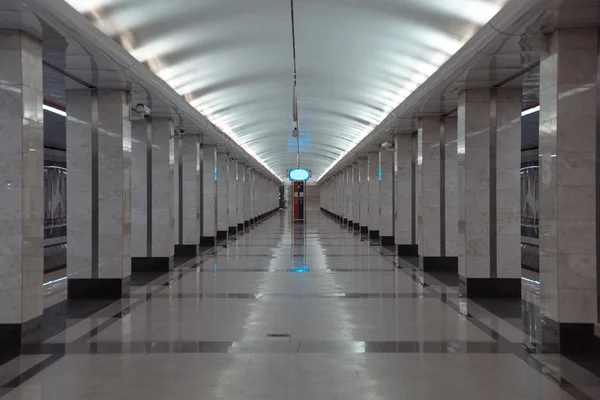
0;315;42;364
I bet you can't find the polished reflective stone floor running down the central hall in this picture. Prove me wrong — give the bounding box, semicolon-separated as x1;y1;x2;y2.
0;210;600;400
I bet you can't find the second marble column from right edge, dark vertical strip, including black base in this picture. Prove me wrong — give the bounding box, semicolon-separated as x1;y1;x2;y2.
457;89;521;297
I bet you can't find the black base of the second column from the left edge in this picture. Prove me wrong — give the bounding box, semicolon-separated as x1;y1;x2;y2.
67;276;131;299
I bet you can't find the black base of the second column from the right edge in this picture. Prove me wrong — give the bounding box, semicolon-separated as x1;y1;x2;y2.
459;276;520;296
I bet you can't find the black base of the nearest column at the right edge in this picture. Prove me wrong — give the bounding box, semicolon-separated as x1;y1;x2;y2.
541;317;600;356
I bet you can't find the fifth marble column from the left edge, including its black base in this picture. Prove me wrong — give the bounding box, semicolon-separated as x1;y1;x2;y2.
200;145;217;247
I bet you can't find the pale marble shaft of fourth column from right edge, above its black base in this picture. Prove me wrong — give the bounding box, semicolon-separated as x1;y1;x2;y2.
394;134;416;245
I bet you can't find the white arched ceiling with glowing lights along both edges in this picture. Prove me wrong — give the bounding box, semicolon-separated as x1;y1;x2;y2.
67;0;508;178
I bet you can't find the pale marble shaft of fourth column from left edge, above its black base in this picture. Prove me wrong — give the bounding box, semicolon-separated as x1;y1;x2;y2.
180;135;202;245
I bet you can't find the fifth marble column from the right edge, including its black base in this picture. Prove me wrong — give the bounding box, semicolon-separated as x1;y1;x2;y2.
379;149;394;246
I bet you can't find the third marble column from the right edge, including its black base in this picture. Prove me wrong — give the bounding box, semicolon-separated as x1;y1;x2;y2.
417;117;458;272
